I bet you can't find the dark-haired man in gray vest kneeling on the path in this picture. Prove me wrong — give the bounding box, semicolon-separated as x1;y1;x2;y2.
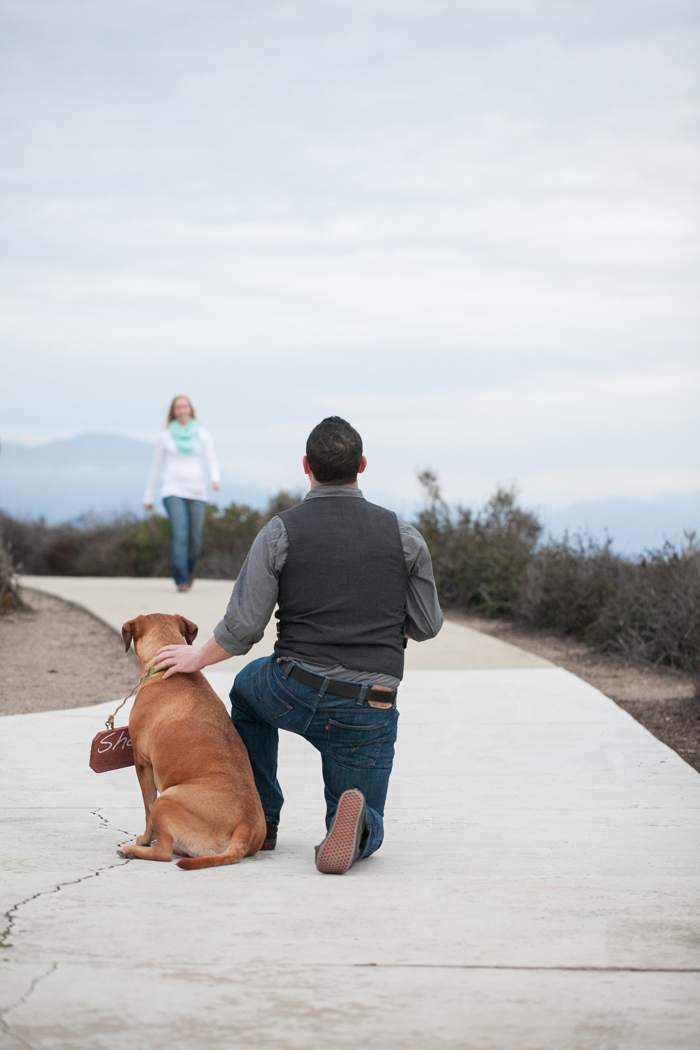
155;416;443;875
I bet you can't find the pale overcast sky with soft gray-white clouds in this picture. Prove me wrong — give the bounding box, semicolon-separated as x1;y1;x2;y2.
0;0;700;507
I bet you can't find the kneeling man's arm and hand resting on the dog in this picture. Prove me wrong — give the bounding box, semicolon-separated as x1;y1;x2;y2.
153;518;289;679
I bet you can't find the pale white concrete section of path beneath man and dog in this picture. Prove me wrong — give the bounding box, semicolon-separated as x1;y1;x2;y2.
0;581;700;1050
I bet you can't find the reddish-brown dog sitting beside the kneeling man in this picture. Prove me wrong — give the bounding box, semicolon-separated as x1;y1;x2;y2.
120;613;266;869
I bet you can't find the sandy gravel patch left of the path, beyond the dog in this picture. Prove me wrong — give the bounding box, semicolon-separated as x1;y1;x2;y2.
0;588;139;715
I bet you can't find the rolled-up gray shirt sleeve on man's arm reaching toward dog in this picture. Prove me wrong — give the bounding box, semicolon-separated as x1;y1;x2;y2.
214;518;289;656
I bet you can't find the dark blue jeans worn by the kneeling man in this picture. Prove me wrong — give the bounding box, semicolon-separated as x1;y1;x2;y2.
231;656;399;857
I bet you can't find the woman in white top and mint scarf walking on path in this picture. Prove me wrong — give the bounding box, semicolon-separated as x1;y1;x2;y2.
144;395;219;591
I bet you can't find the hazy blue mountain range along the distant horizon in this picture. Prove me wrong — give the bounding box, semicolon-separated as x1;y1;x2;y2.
0;434;700;554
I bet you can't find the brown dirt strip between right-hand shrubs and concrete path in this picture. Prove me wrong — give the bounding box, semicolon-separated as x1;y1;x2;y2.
446;612;700;772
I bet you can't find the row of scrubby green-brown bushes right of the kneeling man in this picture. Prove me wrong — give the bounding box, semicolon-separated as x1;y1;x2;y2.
416;470;700;674
